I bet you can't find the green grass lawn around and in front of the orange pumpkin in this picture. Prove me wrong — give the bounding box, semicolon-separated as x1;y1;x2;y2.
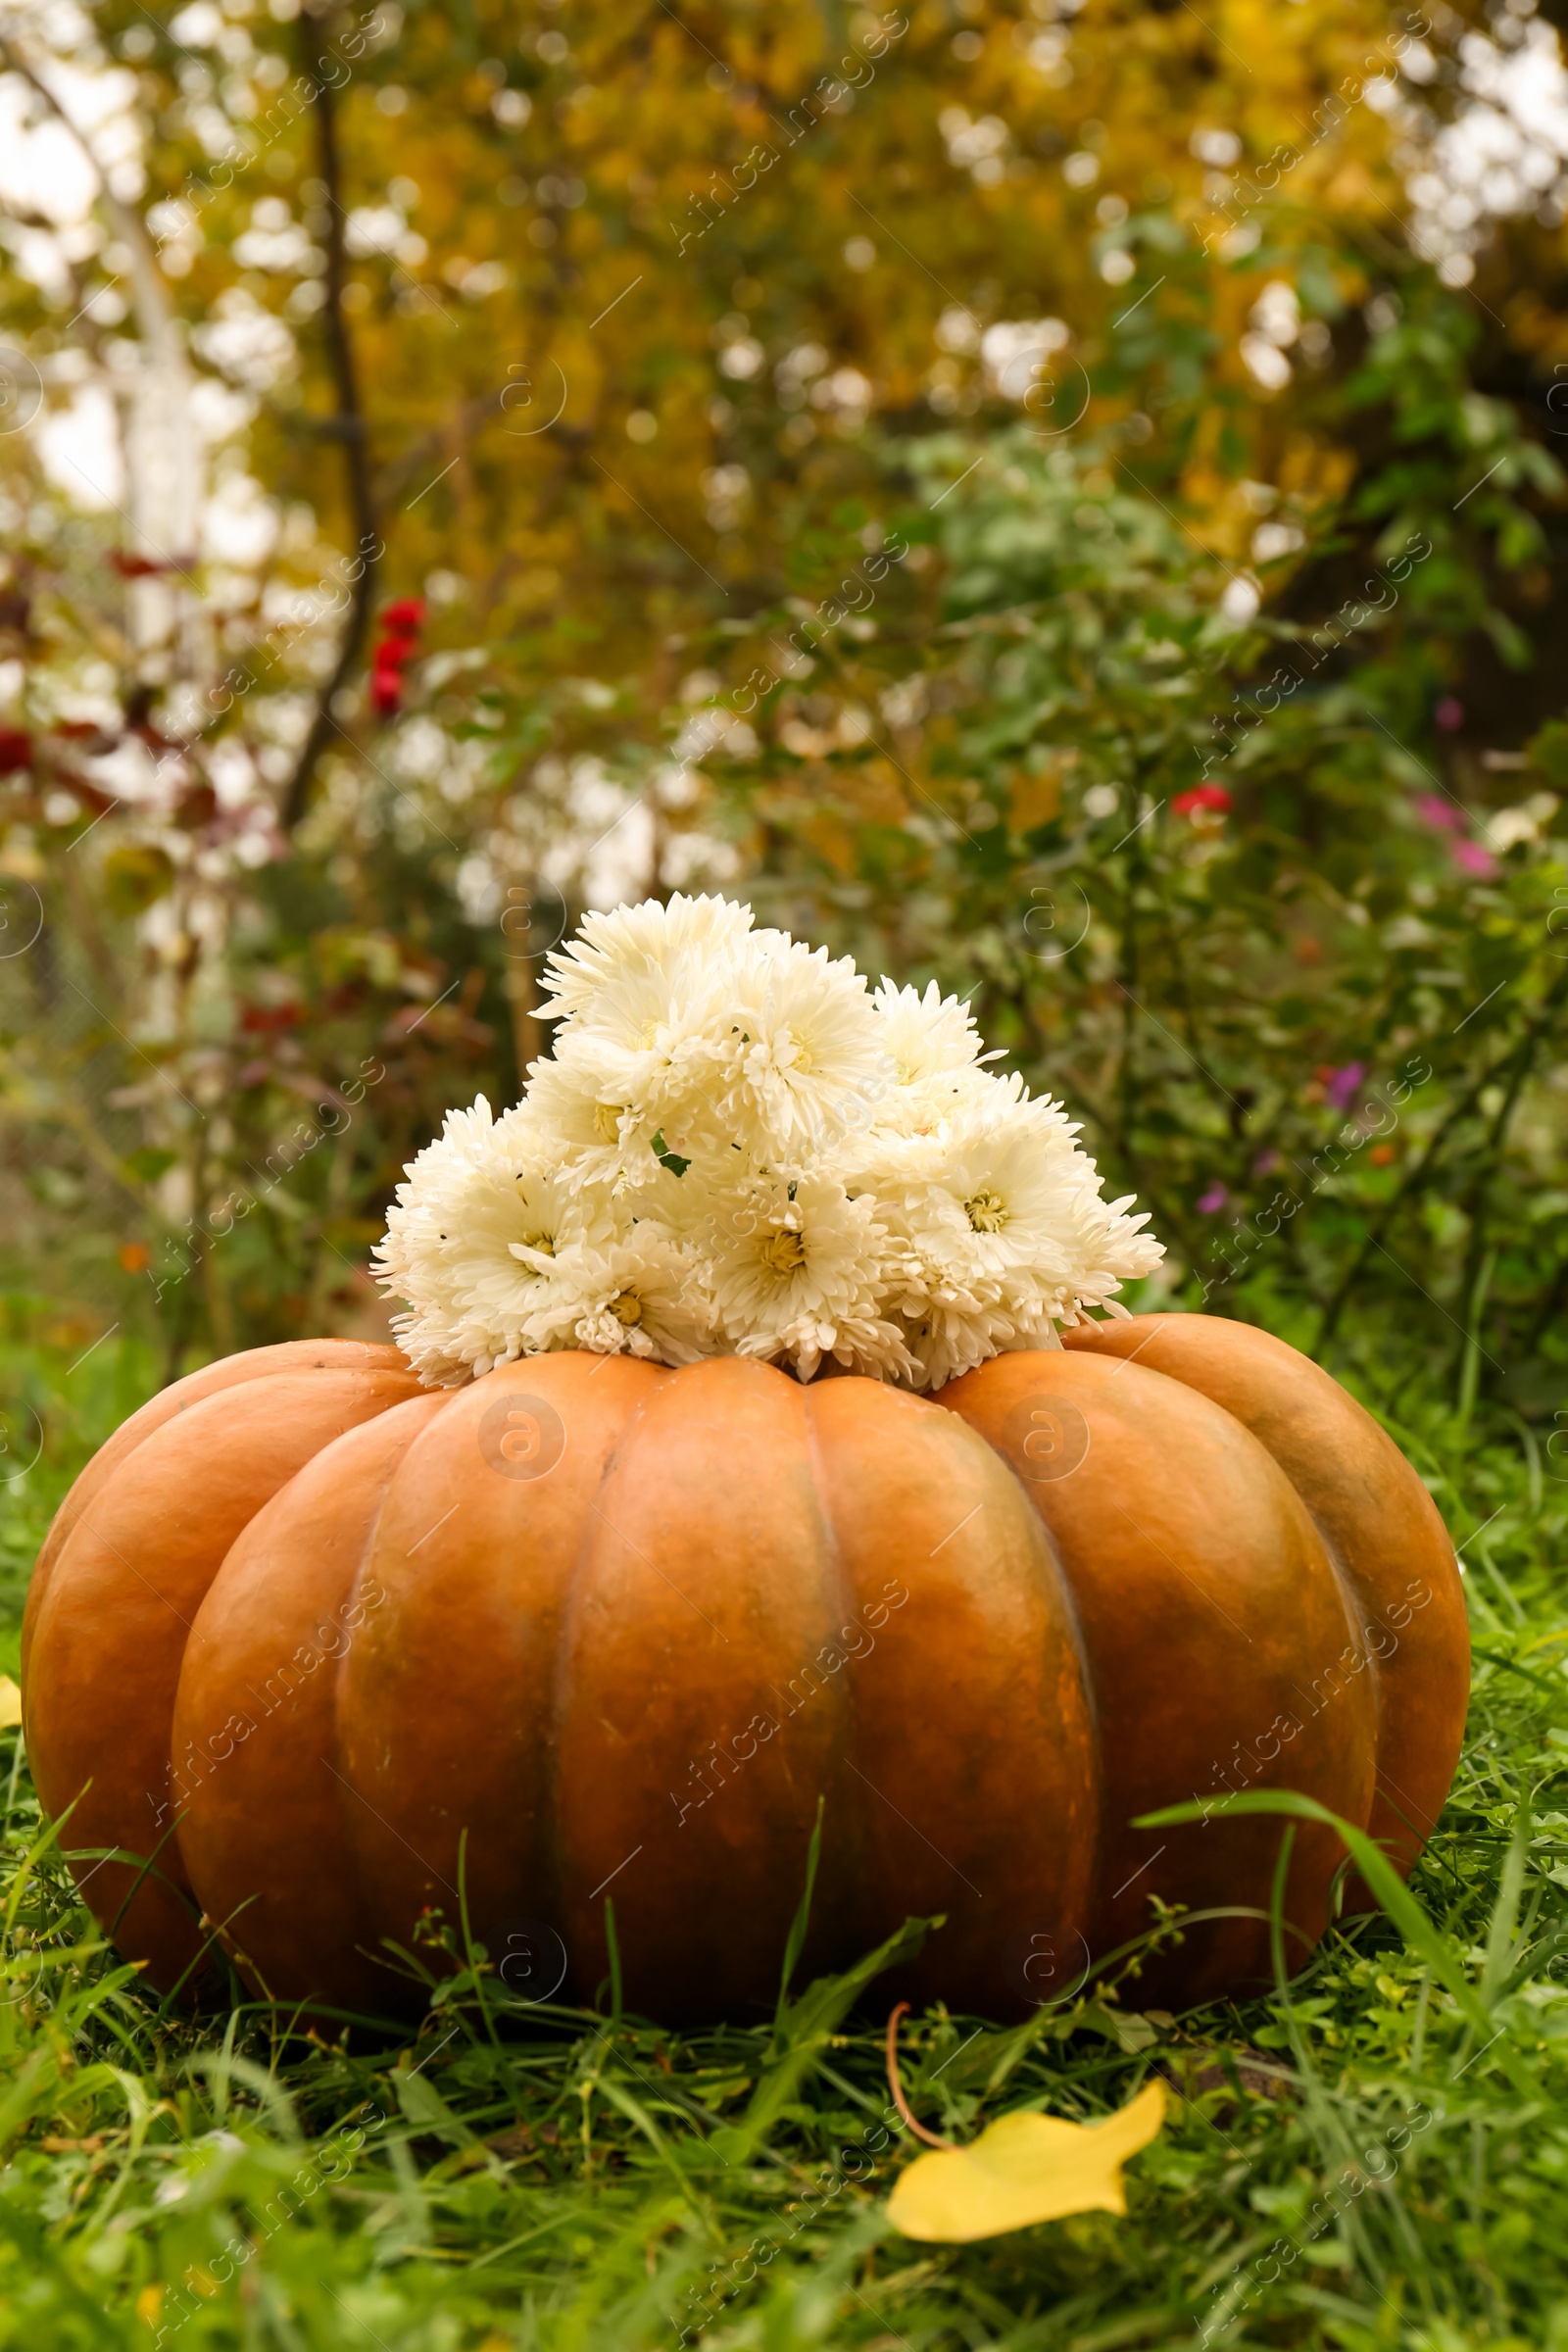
0;1341;1568;2352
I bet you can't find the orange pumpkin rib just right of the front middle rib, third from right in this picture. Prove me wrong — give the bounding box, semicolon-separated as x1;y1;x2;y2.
807;1381;1098;2013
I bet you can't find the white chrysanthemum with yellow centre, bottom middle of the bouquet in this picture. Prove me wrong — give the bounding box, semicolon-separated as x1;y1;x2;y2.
708;1169;914;1381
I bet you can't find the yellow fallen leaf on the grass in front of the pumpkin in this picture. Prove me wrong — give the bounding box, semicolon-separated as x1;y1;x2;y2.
889;2082;1166;2246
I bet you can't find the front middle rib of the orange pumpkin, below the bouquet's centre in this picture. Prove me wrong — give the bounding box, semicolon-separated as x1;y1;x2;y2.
558;1357;856;2021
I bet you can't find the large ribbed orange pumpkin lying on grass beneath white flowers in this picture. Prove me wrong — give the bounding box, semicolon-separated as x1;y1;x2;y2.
24;1315;1467;2023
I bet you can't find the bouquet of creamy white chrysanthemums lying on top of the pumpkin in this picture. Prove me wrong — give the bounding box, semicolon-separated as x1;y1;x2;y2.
378;896;1161;1388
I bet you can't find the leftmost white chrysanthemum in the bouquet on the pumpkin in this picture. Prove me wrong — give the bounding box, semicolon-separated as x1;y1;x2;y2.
376;1096;615;1388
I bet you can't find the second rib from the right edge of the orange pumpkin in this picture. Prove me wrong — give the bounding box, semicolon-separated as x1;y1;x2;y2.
943;1350;1373;2004
